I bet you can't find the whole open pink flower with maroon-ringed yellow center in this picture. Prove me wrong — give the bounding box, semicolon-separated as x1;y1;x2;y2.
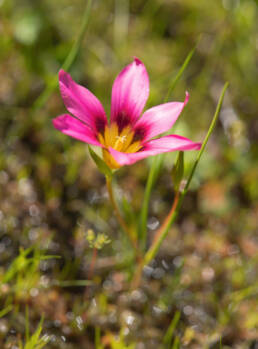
53;58;201;168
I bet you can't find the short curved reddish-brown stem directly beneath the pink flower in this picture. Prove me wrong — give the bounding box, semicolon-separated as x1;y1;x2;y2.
106;176;141;260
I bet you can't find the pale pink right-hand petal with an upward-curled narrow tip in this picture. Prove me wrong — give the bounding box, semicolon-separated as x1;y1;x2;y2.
134;92;189;141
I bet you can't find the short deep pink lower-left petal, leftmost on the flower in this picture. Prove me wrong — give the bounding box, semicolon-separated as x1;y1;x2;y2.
52;114;102;147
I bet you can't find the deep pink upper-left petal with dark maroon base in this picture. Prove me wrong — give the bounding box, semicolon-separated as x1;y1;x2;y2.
59;70;107;132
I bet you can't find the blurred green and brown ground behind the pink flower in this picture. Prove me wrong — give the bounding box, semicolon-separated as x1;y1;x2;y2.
0;0;258;349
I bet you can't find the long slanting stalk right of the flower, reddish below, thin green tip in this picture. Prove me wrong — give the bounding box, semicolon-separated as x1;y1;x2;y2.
132;82;228;288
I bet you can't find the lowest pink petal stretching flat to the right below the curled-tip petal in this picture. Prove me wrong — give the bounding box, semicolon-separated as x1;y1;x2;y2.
109;135;201;165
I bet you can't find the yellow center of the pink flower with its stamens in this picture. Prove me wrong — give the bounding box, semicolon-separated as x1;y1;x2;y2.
98;122;141;169
